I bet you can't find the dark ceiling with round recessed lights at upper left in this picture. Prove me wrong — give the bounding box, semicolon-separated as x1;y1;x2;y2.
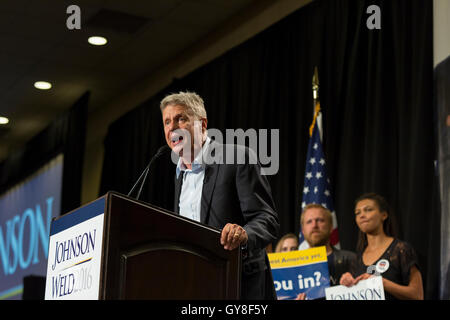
0;0;258;161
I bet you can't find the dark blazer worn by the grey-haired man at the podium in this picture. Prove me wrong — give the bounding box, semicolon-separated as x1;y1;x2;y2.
174;141;279;299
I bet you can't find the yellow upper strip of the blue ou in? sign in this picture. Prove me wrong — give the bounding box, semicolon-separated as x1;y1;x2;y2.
268;246;327;269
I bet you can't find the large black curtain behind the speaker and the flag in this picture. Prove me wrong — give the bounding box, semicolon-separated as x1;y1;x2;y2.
101;0;439;298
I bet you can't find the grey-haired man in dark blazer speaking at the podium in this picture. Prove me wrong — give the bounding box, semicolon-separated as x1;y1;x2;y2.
160;92;279;299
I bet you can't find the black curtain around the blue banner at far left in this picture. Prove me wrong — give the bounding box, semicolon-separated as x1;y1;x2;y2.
0;92;90;213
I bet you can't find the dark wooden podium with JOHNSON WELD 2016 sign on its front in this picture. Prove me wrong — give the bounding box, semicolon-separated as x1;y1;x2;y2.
46;192;241;299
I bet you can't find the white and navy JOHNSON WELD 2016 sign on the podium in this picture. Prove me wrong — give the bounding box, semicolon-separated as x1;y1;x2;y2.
45;197;105;300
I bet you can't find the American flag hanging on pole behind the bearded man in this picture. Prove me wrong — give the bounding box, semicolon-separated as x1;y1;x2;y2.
299;116;339;250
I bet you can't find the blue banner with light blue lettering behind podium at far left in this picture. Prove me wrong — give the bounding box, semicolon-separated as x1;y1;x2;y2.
0;155;63;299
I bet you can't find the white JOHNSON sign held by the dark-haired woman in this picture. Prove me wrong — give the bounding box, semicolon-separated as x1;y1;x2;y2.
325;276;384;300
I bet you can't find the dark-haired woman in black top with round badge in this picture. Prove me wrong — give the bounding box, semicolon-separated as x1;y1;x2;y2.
340;193;423;300
